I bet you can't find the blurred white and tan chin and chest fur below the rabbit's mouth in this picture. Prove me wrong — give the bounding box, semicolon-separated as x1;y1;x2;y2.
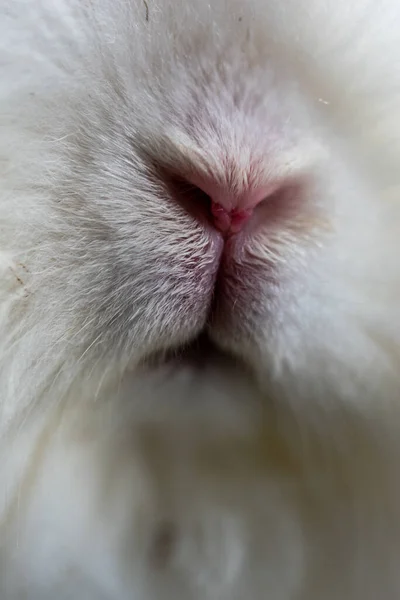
0;342;400;600
